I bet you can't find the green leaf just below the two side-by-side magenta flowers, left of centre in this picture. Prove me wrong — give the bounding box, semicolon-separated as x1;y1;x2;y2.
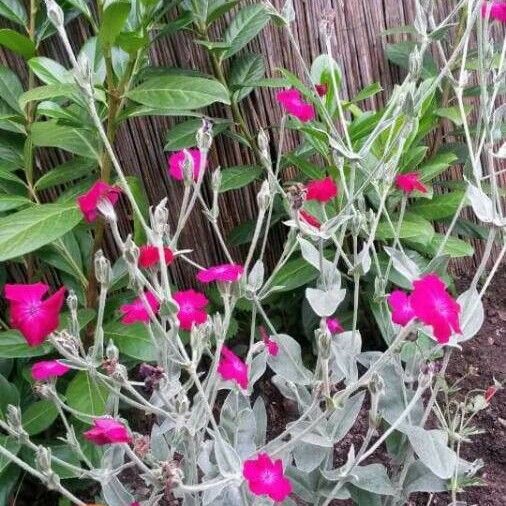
104;322;157;362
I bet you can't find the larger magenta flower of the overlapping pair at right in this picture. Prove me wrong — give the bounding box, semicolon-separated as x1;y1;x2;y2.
411;274;460;344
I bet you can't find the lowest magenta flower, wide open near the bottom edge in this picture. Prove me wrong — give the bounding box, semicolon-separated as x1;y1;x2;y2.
242;453;292;502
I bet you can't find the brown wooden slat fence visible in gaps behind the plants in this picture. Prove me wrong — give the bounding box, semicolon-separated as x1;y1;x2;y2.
0;0;503;283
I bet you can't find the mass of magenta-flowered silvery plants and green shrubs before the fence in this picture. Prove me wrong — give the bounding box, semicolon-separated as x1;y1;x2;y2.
0;0;506;506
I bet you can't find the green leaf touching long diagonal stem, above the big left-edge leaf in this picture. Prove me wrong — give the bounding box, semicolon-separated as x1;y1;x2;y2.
31;121;101;160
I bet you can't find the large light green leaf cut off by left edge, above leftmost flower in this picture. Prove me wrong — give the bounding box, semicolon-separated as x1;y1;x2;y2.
0;202;82;262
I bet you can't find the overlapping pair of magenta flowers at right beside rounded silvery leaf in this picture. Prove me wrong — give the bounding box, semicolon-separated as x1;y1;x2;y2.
388;274;461;344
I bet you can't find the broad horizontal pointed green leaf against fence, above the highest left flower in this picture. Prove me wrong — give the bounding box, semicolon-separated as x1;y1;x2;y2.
127;74;230;111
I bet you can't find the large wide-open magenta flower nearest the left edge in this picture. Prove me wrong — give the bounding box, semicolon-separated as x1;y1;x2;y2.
4;283;65;346
